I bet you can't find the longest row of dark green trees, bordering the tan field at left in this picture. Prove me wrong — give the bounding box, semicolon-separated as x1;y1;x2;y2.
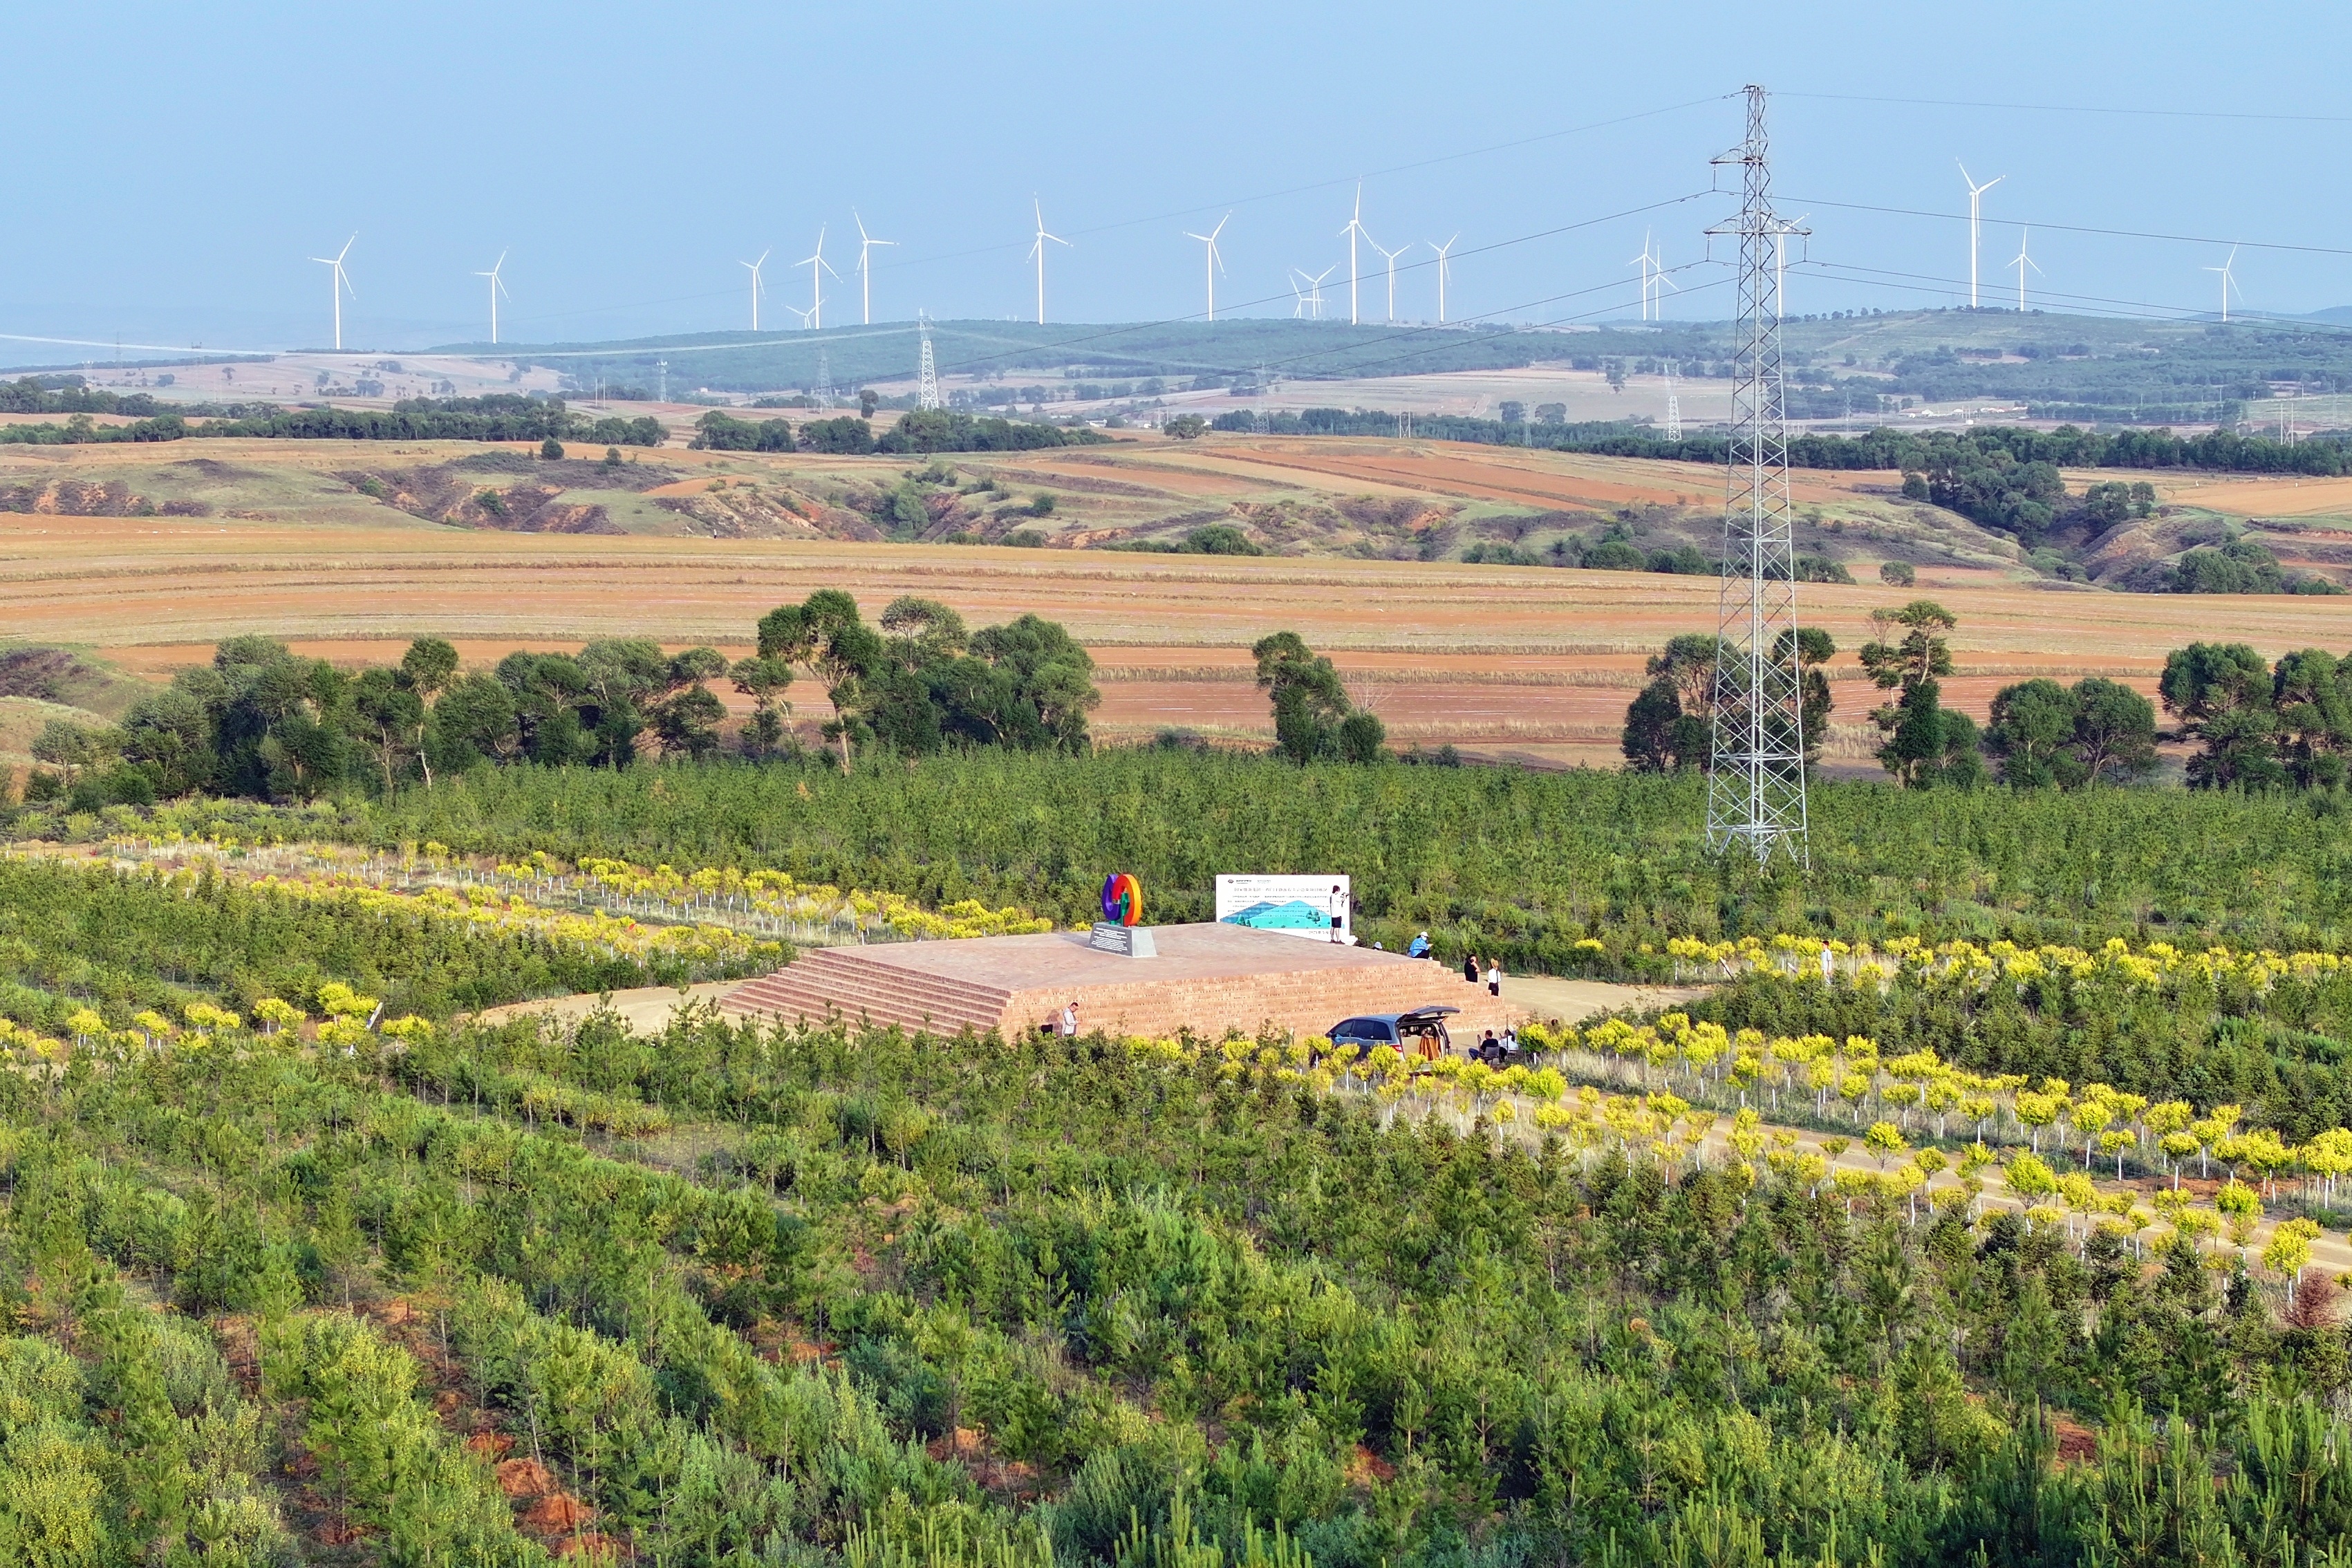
26;590;1101;811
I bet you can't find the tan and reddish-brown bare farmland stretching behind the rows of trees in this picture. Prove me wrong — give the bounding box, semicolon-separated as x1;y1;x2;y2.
0;440;2352;762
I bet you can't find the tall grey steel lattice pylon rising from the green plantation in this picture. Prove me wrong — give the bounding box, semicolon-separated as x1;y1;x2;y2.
1708;87;1809;865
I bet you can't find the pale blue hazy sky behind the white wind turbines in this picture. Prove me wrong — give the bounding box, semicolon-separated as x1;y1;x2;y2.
18;0;2352;364
